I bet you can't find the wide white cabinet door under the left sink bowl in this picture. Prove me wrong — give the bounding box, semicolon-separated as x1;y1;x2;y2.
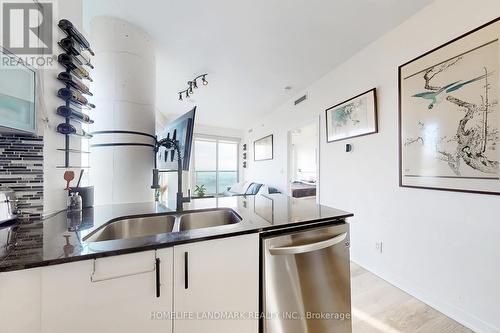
41;248;173;333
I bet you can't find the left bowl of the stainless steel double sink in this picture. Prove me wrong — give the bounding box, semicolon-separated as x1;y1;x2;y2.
83;215;176;242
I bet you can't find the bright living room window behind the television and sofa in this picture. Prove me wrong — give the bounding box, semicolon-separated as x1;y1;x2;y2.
193;137;239;195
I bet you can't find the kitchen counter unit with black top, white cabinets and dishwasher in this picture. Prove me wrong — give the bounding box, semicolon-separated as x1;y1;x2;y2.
0;194;352;333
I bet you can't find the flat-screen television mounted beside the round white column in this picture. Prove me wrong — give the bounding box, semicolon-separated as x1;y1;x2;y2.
157;107;196;171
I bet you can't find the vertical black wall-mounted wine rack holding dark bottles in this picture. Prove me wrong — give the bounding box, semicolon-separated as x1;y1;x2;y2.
56;19;95;169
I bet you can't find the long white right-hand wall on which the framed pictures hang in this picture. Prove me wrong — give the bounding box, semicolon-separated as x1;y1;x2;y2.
245;0;500;332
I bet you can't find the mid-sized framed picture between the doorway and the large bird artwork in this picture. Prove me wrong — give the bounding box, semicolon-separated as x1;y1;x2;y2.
325;88;378;143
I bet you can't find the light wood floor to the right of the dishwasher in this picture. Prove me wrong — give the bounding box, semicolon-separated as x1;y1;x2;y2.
351;263;473;333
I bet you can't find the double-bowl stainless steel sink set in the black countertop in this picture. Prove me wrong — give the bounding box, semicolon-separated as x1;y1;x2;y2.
83;208;241;242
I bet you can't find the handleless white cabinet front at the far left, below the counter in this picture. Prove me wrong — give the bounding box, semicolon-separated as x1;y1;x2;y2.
0;268;41;333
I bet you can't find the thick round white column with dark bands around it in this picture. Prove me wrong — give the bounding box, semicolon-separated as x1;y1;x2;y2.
90;16;156;204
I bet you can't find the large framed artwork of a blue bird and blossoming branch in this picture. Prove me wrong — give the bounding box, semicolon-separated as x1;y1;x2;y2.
398;18;500;195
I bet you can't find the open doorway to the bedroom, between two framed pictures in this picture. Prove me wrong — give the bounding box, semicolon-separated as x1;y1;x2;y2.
288;119;319;202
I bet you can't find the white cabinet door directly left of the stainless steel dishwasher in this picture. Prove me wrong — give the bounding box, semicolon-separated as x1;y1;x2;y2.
174;234;259;333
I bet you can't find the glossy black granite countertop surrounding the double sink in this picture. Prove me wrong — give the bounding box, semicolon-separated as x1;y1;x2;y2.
0;194;353;272
